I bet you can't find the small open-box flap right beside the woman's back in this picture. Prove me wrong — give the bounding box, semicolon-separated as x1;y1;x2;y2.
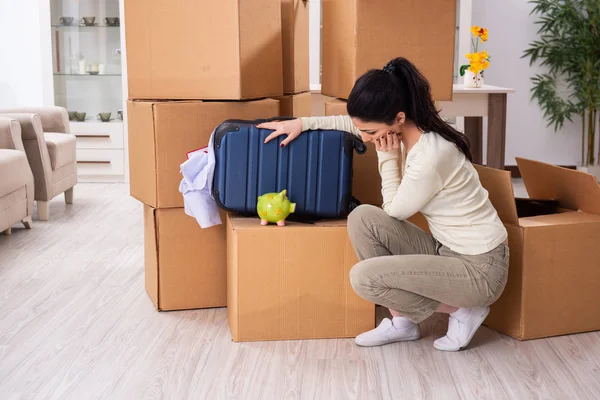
474;165;519;225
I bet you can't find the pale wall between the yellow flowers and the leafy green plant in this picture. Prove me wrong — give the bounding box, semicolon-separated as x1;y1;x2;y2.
472;0;581;165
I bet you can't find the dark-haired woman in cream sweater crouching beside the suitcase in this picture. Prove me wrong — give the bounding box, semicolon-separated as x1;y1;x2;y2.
260;58;509;351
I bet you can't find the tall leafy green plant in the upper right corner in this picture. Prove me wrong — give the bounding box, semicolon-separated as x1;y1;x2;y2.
523;0;600;178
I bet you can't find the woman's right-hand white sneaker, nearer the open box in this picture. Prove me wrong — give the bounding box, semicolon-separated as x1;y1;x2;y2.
433;307;490;351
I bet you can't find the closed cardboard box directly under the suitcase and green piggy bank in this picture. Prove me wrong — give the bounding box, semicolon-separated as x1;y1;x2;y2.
227;215;375;342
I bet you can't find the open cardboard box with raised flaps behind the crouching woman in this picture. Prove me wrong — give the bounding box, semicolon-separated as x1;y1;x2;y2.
476;158;600;340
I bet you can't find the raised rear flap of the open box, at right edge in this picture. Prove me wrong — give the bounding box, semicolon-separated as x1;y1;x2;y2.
517;157;600;214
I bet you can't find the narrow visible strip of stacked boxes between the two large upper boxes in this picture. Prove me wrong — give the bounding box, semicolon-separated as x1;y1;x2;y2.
277;0;311;117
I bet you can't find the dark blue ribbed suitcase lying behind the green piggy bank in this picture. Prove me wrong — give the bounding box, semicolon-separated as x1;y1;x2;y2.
213;117;366;219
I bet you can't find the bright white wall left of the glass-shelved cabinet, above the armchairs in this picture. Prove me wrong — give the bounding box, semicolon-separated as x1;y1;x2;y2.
0;0;54;108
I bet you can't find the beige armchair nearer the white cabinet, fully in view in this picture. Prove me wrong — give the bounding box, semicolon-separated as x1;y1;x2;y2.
0;106;77;221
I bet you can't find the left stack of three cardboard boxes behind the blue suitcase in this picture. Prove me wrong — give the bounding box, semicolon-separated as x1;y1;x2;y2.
125;0;283;310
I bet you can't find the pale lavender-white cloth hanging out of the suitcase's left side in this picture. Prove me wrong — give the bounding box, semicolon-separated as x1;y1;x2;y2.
179;132;222;228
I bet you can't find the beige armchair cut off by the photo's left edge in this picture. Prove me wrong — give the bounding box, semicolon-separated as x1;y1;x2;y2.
0;117;33;235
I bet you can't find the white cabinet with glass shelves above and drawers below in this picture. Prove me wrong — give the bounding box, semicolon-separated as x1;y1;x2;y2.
49;0;129;182
